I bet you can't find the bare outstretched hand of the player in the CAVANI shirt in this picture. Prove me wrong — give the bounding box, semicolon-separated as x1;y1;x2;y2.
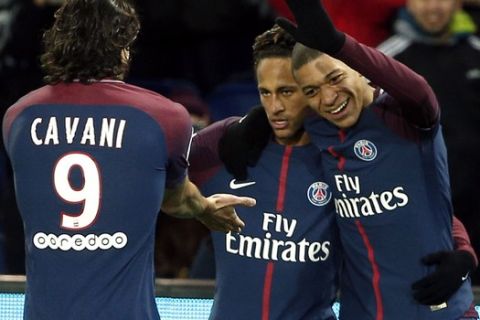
196;194;256;233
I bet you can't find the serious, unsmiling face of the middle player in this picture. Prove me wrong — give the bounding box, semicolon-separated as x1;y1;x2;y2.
255;57;309;145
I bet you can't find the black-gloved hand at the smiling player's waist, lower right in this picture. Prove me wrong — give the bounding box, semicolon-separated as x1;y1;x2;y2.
412;250;475;305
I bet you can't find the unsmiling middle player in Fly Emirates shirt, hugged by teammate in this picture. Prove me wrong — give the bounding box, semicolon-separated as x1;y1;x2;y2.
189;26;341;320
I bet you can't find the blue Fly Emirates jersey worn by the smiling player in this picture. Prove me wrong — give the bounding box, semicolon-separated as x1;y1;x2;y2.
306;38;473;320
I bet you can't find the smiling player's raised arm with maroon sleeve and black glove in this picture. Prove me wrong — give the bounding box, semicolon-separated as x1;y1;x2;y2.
277;0;439;128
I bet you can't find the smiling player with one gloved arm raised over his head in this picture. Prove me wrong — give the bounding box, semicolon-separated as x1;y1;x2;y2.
219;0;478;320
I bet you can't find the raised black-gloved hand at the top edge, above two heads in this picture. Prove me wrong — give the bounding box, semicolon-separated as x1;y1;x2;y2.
276;0;345;54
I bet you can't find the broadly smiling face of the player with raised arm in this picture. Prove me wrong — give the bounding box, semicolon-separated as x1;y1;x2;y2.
294;54;374;128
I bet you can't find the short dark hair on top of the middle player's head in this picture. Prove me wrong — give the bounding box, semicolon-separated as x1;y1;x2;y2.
252;24;296;70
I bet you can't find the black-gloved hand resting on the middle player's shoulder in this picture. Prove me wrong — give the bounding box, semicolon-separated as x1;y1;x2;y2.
218;106;272;180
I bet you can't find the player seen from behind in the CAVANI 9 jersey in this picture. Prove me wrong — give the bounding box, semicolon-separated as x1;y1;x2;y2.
3;0;254;320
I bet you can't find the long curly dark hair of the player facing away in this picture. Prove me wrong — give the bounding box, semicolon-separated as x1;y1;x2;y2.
41;0;140;84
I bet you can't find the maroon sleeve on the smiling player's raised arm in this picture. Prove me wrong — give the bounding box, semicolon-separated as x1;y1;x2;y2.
335;35;440;128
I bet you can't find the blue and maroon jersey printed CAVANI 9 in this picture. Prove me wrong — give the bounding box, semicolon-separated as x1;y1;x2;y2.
3;81;191;320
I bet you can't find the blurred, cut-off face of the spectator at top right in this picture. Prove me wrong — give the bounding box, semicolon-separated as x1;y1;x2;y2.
406;0;460;34
